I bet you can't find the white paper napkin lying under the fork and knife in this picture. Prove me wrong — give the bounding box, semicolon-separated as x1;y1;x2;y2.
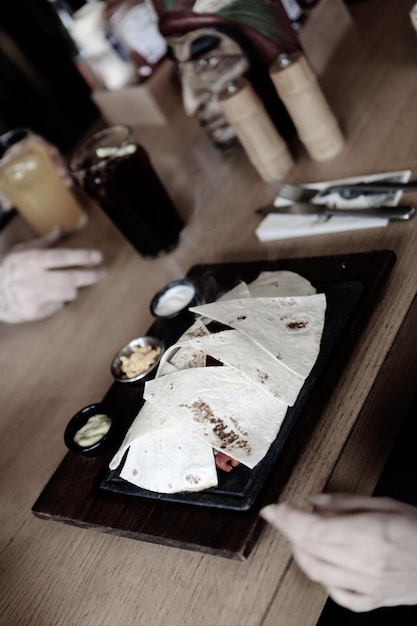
255;170;411;241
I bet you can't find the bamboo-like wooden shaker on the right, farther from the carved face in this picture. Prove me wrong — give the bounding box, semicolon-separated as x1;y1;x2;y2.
269;52;345;161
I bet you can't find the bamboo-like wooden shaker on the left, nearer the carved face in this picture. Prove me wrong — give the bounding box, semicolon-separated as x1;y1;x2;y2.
218;78;294;183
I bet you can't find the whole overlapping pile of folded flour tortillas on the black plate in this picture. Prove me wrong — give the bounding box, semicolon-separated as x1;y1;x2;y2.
110;271;326;494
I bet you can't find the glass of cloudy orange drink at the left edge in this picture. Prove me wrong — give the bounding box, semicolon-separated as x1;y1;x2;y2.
0;128;87;235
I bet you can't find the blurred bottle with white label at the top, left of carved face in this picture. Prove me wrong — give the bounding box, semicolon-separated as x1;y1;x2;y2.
105;0;167;82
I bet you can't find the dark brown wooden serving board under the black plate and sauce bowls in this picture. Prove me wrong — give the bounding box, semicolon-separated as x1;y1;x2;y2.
32;250;396;560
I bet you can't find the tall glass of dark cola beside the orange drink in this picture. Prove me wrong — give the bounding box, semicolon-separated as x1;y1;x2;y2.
71;125;183;258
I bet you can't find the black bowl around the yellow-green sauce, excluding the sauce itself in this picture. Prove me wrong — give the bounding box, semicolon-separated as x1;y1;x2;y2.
64;402;116;457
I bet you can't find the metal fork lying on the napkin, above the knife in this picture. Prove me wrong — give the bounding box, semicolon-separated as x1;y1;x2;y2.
273;181;417;202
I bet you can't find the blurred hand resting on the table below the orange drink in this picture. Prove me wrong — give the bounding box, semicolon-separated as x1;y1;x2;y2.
0;231;106;323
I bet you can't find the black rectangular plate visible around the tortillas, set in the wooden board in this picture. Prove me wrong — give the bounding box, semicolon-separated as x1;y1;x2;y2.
101;281;363;511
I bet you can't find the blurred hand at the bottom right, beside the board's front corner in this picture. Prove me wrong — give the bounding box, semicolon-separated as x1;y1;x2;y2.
261;494;417;612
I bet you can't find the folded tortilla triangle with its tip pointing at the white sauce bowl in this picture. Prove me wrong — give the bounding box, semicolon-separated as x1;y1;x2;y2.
190;294;326;378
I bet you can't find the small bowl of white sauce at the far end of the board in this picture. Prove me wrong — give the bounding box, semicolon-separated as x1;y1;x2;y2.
150;279;198;319
